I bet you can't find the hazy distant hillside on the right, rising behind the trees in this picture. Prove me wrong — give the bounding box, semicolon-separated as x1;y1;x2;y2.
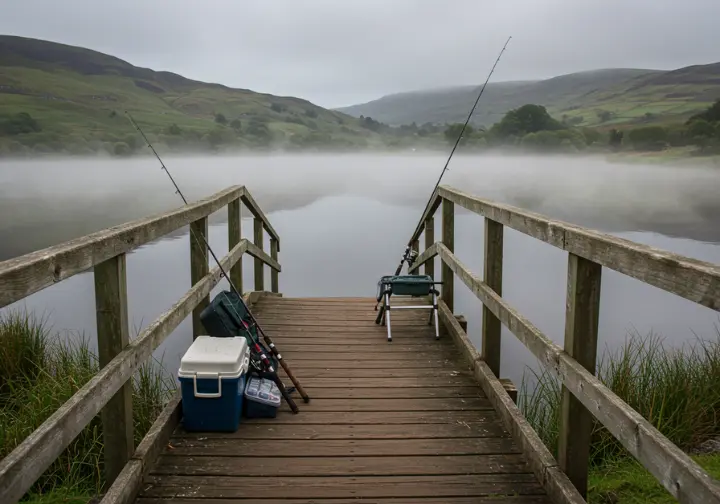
337;63;720;126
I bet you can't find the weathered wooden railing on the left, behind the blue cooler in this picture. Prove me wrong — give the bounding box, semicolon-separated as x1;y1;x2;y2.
0;186;281;504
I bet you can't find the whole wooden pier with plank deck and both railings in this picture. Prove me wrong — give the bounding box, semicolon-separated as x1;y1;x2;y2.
0;186;720;504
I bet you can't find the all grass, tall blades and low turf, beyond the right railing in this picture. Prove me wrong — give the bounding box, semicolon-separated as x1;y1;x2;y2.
519;334;720;504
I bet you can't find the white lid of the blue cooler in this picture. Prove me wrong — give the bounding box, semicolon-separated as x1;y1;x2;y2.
178;336;250;377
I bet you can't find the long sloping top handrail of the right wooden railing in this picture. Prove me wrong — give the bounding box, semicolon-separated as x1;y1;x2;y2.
438;186;720;311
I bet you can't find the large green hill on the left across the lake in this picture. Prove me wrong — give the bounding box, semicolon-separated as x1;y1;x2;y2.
0;36;382;154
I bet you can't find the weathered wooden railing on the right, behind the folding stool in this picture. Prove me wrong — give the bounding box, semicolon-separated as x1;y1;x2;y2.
411;186;720;503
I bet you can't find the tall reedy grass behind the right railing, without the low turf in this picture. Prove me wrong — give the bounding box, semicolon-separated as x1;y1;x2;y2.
520;333;720;466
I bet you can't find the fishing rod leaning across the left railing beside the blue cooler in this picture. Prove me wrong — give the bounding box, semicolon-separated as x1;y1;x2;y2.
125;110;310;413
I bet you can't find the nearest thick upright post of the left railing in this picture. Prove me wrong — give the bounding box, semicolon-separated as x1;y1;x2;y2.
94;254;135;488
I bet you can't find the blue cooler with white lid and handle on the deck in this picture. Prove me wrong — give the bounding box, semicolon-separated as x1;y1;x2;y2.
178;336;250;432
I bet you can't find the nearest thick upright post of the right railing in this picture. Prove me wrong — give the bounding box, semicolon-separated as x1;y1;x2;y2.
558;254;602;497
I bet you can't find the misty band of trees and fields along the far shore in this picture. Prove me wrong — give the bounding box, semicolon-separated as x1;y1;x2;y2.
0;99;720;164
